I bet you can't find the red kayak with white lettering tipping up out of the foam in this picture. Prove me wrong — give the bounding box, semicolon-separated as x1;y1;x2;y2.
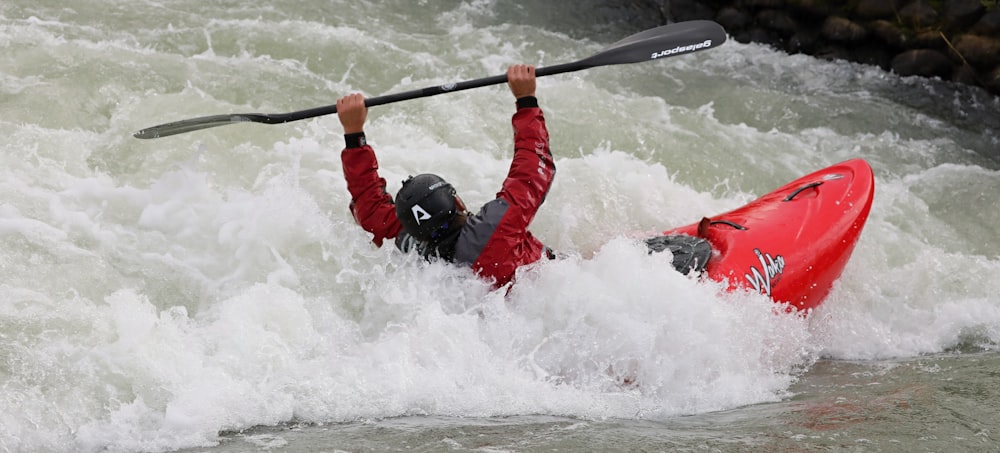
647;159;875;310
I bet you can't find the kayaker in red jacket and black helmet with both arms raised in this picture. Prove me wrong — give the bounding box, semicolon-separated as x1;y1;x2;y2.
337;65;556;287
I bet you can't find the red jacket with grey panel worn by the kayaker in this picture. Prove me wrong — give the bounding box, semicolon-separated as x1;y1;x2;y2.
341;98;556;287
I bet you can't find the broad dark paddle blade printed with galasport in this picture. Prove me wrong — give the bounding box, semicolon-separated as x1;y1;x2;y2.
580;20;726;67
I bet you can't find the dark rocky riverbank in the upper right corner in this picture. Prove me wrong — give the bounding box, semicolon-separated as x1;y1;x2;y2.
657;0;1000;96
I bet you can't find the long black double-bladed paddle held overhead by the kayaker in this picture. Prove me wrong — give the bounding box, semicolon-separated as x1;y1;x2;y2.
133;20;726;138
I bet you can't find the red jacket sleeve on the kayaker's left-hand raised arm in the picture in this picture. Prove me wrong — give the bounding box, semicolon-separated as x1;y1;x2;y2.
340;145;402;247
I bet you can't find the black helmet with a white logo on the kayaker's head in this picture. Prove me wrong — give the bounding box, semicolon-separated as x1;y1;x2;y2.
396;174;465;242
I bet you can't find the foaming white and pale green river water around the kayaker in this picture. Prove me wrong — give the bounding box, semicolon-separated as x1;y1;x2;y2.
0;0;1000;452
